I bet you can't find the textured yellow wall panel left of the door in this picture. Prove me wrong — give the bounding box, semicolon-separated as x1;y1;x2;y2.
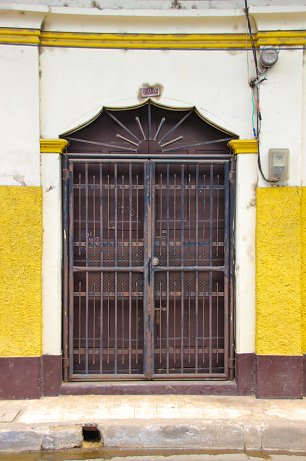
0;186;42;357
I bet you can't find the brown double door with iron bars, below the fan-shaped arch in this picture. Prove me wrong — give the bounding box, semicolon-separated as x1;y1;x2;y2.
64;159;230;380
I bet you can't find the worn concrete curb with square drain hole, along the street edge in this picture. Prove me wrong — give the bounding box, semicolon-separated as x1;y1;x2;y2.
0;420;306;454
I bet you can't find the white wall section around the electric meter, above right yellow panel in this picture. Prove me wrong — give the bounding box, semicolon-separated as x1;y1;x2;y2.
259;50;303;187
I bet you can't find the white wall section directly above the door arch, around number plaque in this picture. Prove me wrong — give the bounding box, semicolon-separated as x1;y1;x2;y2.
41;48;252;138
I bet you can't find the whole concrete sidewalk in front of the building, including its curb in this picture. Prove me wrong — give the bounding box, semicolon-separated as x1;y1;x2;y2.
0;395;306;454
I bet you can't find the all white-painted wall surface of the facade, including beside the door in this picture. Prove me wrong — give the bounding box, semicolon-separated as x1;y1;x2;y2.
0;0;306;360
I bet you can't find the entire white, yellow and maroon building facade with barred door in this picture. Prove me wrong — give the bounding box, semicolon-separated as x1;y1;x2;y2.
0;0;306;398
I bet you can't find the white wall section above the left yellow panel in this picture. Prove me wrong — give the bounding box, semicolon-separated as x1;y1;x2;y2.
0;45;40;186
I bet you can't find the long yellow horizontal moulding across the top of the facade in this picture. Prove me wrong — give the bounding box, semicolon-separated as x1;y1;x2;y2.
0;28;306;49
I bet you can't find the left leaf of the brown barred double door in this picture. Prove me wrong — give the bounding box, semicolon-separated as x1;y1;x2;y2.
69;160;145;380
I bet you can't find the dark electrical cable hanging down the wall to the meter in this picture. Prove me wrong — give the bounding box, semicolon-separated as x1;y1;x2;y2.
244;0;279;184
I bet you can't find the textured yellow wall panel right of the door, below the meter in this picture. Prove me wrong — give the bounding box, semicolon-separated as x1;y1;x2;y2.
256;187;302;355
